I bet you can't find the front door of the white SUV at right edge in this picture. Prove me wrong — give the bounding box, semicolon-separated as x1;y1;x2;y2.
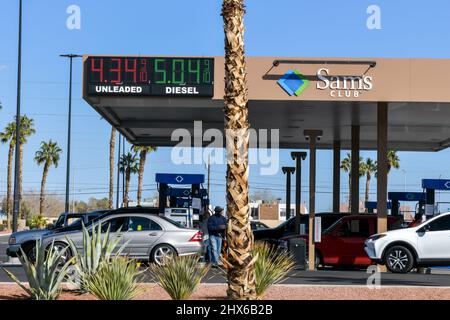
417;215;450;260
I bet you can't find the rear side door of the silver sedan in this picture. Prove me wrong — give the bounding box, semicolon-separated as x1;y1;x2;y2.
123;216;164;258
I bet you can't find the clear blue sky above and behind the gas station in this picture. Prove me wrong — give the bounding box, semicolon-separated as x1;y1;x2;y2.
0;0;450;211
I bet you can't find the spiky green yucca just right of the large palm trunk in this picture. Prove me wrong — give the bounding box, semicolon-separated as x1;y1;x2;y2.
253;243;295;299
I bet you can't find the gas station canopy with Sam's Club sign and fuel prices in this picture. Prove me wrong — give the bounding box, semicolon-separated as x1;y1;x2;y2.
83;56;450;151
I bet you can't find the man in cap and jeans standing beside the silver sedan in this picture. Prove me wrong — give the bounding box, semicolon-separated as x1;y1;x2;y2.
208;206;227;266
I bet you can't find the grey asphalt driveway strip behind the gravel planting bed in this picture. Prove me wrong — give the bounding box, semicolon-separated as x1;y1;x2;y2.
0;265;450;287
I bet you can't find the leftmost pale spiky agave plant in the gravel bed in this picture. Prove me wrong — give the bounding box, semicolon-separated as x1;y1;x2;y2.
2;240;73;300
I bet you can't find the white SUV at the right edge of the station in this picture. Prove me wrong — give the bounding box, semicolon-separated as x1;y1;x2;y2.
364;212;450;273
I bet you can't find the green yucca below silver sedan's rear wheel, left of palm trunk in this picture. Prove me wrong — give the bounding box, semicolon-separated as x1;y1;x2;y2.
149;255;209;300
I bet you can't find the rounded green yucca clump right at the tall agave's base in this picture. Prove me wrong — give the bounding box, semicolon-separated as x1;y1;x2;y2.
86;257;142;300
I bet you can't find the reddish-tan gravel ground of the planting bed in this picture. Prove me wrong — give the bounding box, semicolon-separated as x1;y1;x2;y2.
0;284;450;300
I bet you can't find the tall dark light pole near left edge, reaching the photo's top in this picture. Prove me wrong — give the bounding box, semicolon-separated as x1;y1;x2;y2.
11;0;22;232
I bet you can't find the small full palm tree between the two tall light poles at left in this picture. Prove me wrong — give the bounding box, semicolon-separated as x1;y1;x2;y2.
34;140;62;215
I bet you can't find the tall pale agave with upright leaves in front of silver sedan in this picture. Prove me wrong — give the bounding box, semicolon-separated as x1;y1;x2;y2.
67;223;125;290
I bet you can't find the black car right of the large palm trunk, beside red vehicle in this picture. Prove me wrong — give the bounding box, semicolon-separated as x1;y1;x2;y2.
253;212;348;245
